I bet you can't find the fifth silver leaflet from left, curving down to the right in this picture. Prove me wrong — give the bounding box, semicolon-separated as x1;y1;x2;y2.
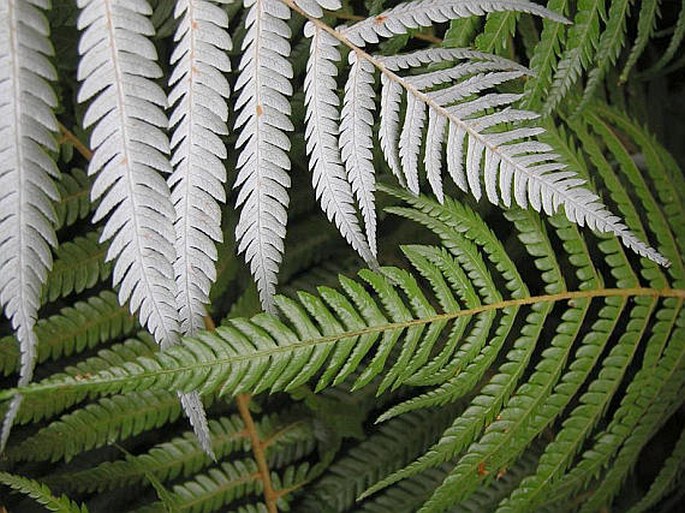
305;25;376;266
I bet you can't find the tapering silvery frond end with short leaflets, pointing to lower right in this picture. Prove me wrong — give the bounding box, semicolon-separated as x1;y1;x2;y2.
378;50;667;264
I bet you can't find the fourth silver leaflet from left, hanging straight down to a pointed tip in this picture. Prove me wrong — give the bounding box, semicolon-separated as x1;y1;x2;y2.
235;0;293;312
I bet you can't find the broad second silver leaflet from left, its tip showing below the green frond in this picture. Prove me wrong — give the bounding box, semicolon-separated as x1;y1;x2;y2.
78;0;212;455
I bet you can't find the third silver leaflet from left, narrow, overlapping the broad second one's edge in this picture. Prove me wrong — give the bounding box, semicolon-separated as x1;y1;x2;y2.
168;0;232;335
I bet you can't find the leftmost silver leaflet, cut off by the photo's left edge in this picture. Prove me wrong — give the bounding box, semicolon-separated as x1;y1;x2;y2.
0;0;58;452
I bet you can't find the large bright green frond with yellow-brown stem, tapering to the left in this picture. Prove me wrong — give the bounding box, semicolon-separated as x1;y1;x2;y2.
0;101;685;512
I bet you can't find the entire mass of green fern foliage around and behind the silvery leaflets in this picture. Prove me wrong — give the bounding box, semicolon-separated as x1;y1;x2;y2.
0;0;685;513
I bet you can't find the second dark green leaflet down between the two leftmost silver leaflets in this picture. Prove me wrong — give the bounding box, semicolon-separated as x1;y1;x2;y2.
43;232;112;302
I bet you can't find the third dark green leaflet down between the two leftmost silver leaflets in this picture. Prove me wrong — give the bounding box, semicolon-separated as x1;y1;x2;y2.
0;291;137;375
